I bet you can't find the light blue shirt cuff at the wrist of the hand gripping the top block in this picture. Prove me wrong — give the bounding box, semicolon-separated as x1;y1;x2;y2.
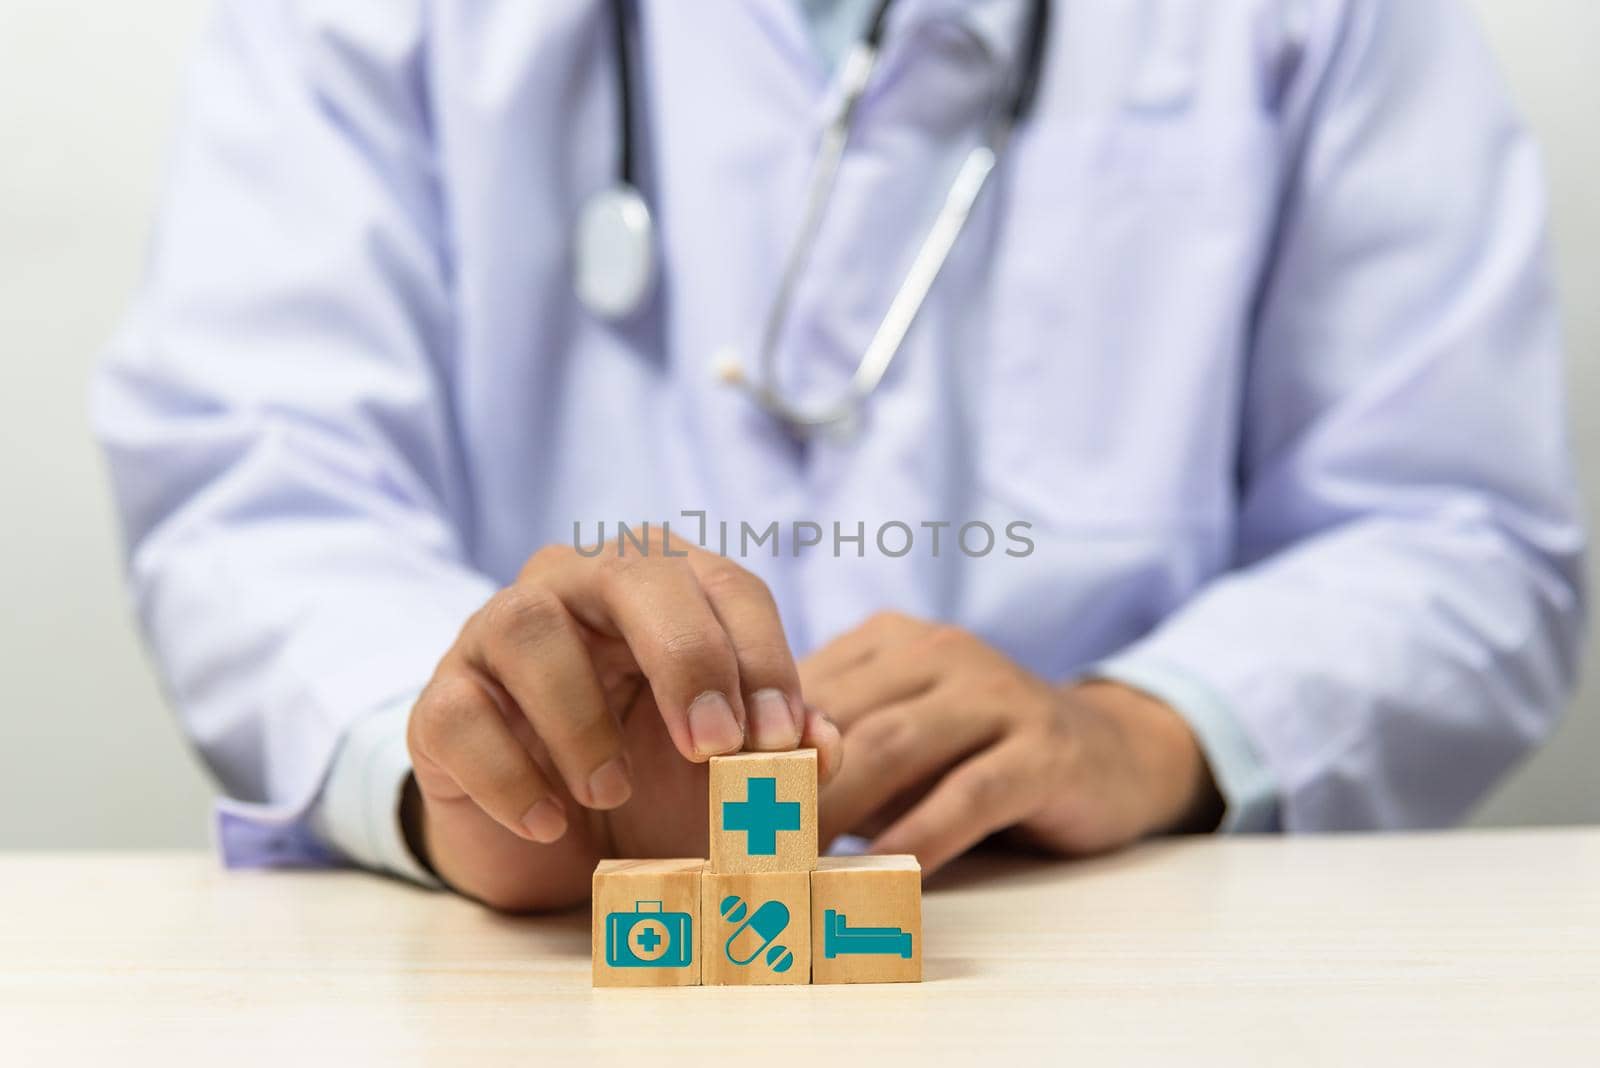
309;694;442;889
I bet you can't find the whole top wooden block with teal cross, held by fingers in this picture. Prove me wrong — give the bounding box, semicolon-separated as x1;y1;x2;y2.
710;750;816;875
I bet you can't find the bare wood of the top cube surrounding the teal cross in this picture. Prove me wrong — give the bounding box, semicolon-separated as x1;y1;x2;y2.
709;750;816;873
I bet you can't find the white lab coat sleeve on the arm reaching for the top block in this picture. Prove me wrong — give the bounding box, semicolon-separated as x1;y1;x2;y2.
93;0;494;863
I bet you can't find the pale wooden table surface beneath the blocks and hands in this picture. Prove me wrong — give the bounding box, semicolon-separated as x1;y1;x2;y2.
0;830;1600;1068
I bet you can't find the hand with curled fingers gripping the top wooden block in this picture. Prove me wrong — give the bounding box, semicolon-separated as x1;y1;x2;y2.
406;540;840;911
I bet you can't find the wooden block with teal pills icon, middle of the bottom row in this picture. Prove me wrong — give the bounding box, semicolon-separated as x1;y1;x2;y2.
701;868;811;986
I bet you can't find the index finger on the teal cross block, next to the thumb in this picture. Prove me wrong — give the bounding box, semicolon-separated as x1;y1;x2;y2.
690;553;806;750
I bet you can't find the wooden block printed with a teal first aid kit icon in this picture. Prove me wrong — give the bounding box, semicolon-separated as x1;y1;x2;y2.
592;859;706;986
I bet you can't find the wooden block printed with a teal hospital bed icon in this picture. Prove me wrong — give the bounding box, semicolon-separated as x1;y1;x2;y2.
811;857;922;983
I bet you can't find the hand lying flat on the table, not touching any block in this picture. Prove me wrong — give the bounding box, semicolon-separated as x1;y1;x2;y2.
800;614;1222;871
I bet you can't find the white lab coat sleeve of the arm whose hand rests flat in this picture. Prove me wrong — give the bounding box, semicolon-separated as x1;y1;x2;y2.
1104;0;1584;831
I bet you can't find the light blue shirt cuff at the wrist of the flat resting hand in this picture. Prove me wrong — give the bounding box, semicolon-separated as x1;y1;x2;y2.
1085;651;1278;833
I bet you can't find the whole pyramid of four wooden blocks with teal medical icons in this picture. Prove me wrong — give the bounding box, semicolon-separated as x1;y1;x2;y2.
594;750;922;986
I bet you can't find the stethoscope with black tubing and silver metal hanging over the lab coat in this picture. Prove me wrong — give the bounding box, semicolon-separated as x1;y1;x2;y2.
573;0;1050;438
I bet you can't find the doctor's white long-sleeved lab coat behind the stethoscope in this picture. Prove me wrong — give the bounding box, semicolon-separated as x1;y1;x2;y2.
94;0;1584;876
